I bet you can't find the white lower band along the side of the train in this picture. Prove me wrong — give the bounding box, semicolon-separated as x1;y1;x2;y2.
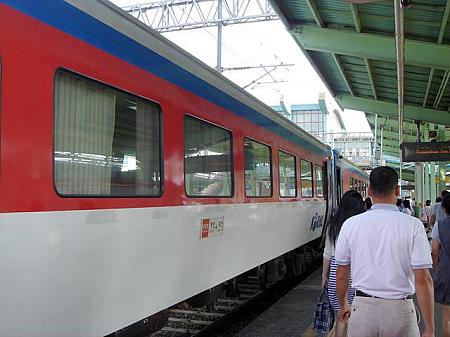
0;201;325;337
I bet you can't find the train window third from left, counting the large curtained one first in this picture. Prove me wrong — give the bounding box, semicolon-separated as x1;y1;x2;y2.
244;138;272;197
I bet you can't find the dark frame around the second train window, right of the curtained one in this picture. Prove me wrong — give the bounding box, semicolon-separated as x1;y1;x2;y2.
183;114;235;199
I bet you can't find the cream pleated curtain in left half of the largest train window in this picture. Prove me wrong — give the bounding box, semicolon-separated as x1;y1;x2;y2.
55;72;116;195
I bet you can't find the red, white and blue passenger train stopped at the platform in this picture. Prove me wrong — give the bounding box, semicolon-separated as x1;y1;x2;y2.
0;0;367;337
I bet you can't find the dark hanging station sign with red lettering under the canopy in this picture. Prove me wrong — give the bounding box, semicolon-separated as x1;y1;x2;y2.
400;142;450;162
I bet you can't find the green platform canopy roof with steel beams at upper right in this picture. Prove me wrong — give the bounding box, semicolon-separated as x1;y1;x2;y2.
270;0;450;157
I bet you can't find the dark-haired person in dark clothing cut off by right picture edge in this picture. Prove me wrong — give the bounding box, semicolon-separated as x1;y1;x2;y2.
431;194;450;337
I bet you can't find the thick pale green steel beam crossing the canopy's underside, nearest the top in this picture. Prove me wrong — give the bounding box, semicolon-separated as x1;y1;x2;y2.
291;26;450;70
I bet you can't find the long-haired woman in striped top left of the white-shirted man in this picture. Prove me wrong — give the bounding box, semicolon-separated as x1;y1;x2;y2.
322;190;366;337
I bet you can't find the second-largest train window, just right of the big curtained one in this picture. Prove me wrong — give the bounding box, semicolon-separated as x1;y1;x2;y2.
184;116;233;197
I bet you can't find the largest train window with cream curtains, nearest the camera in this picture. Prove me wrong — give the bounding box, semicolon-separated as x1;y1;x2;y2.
54;71;161;197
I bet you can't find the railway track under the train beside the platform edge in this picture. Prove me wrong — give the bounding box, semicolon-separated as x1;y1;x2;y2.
149;249;320;337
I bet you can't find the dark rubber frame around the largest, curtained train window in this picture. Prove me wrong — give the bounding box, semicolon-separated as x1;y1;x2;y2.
52;67;165;199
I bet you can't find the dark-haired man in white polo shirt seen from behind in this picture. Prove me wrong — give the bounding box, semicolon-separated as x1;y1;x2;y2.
335;166;434;337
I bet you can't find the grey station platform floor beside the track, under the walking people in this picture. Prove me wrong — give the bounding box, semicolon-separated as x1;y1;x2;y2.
234;268;441;337
